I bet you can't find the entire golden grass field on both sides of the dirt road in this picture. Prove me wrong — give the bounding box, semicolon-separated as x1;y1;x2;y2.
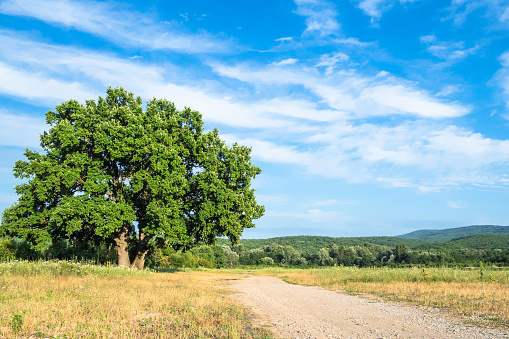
0;261;509;338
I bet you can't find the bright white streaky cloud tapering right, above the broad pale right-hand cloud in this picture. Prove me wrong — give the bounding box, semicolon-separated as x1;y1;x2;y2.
212;64;470;118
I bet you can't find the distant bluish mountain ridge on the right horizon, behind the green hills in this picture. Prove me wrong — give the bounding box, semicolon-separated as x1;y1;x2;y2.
397;225;509;243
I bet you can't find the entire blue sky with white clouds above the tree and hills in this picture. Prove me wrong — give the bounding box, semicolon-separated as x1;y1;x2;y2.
0;0;509;238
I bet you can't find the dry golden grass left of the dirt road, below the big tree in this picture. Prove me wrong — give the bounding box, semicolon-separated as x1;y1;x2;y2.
0;267;270;338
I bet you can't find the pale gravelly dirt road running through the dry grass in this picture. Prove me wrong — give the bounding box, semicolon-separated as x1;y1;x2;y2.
230;276;509;339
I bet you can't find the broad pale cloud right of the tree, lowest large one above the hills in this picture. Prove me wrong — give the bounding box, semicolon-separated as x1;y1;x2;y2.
226;120;509;193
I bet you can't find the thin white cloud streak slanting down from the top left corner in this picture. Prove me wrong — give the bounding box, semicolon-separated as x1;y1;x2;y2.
0;0;234;53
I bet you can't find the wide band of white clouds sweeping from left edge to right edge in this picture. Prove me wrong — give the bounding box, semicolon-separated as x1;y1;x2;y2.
0;31;509;192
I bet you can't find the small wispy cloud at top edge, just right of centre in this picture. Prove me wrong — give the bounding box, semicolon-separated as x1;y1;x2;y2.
294;0;340;36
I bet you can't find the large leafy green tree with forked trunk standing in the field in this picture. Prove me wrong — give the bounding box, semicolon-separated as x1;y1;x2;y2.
0;88;264;269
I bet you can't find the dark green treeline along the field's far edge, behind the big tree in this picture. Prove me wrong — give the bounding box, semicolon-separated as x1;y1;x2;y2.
0;235;509;268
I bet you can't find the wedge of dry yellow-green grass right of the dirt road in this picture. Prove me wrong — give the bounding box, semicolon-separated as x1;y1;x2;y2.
254;267;509;327
